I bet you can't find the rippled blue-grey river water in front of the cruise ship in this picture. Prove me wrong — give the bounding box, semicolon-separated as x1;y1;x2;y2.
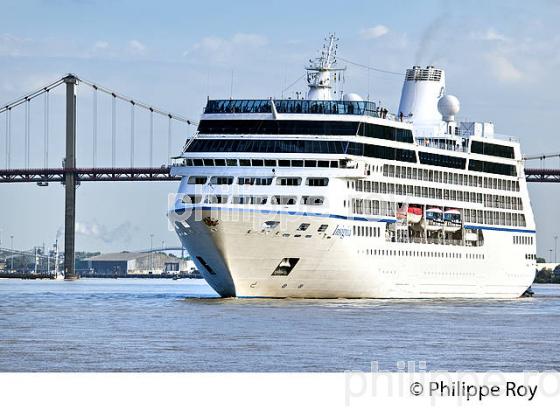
0;279;560;372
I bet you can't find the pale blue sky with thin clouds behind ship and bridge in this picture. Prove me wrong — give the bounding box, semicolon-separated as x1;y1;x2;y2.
0;0;560;258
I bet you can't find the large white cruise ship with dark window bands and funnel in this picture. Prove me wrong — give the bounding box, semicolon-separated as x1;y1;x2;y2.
169;35;536;298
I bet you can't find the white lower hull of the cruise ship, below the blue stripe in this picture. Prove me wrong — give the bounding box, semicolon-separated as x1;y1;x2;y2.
175;206;535;298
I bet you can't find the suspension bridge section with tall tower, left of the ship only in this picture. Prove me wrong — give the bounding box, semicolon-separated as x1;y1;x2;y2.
0;74;196;279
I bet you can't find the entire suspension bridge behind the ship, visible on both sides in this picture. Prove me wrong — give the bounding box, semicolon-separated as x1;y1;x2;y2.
0;74;560;279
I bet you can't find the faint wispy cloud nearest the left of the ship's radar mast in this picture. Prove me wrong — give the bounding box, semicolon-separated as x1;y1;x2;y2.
183;33;268;62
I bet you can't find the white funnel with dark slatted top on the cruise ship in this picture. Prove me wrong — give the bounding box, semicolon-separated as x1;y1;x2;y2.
399;66;445;124
